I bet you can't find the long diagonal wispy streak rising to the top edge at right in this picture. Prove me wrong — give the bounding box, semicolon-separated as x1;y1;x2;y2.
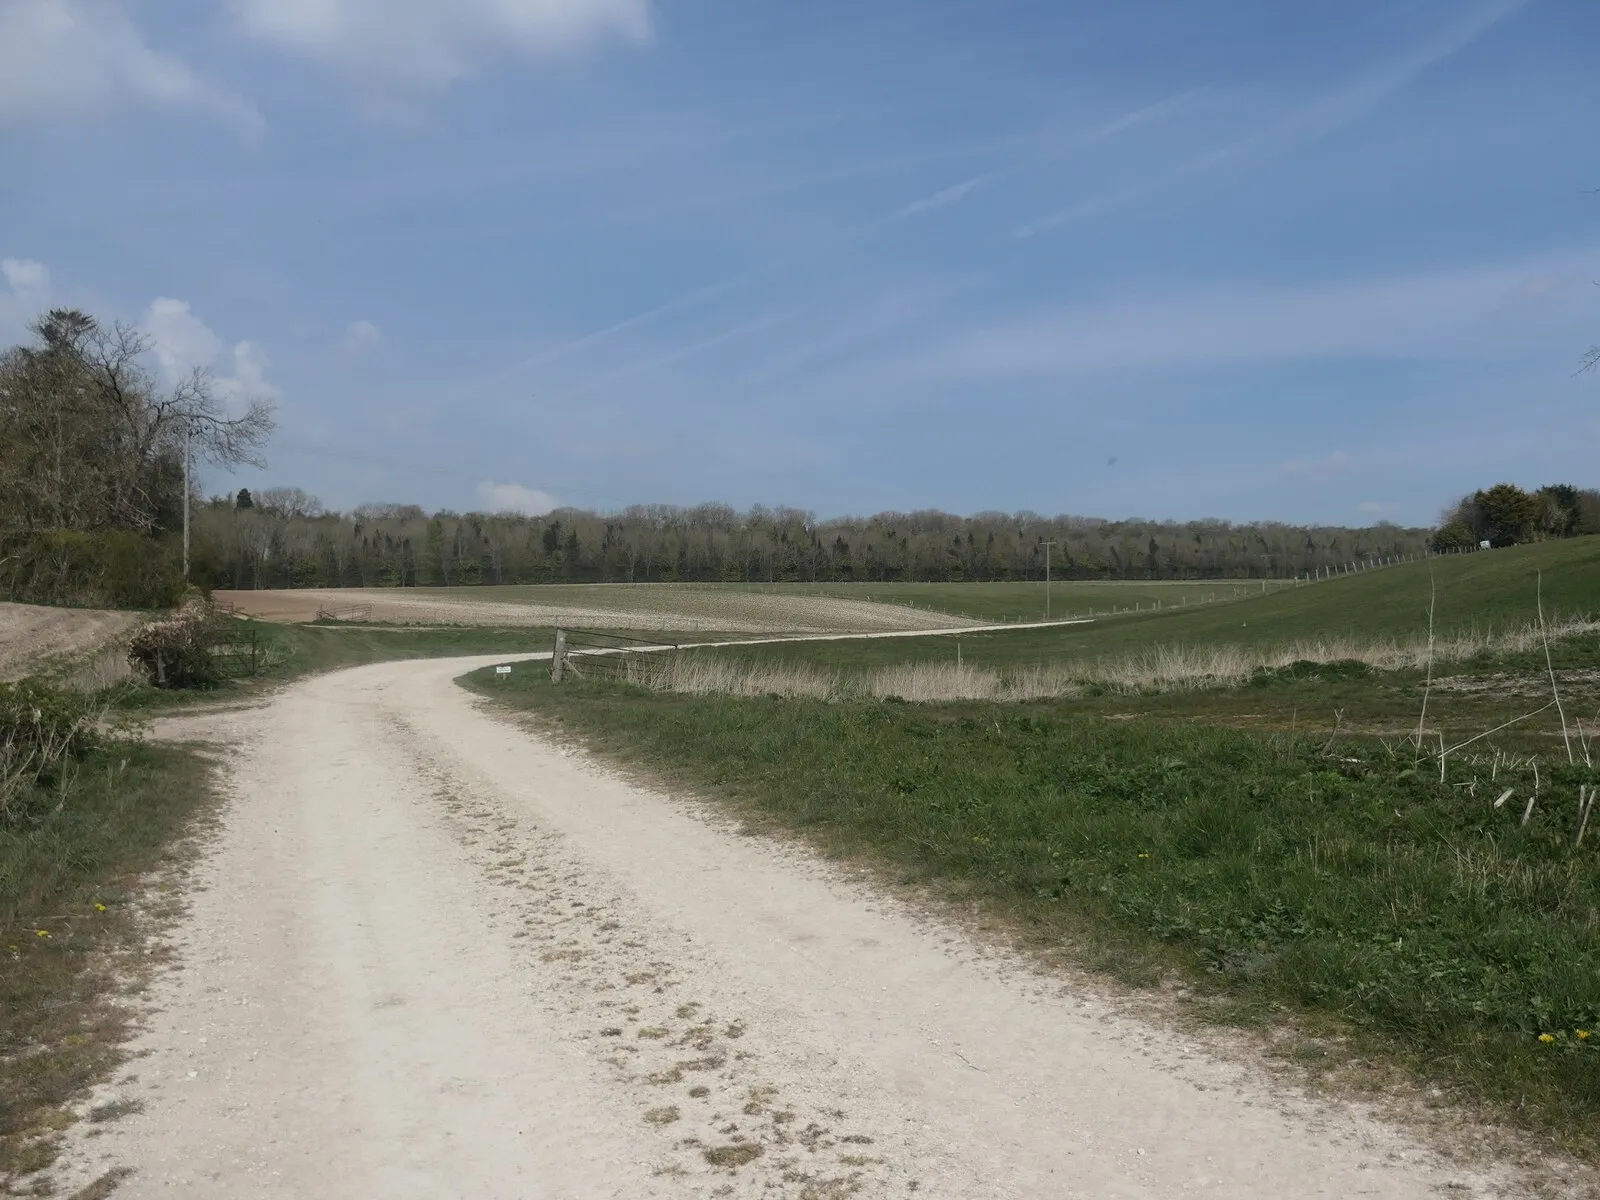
1011;0;1528;238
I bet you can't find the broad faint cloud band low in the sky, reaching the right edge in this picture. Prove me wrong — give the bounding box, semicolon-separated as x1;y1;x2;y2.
910;250;1600;376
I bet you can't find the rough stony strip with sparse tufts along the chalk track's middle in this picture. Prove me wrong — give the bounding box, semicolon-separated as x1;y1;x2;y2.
390;718;918;1200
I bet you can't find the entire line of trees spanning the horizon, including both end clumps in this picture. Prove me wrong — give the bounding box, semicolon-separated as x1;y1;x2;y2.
0;309;1600;606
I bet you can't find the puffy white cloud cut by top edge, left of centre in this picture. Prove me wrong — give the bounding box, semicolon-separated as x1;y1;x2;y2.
232;0;651;90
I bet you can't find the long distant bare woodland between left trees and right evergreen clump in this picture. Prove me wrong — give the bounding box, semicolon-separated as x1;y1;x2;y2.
197;490;1429;587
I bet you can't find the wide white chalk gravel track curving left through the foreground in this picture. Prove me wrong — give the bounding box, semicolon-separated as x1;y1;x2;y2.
58;659;1506;1200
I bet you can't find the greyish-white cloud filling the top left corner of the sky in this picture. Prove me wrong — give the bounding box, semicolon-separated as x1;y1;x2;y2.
0;0;264;134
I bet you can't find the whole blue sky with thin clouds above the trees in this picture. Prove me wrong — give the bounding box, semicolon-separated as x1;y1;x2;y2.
0;0;1600;523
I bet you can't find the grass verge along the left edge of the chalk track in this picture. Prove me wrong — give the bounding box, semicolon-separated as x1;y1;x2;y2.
0;741;211;1184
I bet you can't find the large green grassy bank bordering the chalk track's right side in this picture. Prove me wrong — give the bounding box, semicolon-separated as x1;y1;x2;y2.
474;672;1600;1157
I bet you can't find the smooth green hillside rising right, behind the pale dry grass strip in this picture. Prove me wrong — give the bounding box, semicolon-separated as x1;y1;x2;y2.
704;538;1600;678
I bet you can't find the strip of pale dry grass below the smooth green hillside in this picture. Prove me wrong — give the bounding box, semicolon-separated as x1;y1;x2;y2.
624;618;1600;702
